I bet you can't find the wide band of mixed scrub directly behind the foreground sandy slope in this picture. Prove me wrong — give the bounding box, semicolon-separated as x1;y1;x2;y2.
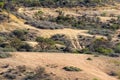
0;29;119;57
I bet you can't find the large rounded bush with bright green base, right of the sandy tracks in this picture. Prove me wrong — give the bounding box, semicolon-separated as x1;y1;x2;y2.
87;38;114;56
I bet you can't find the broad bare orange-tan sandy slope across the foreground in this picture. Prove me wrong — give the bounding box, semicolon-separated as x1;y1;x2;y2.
0;52;119;80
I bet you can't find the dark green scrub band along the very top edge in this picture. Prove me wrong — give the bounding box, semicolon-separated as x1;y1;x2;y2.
0;0;119;8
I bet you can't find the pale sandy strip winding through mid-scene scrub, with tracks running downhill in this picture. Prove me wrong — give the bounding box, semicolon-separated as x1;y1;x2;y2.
0;12;106;49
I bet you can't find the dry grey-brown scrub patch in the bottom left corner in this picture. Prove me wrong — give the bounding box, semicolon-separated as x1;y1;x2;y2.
0;65;57;80
